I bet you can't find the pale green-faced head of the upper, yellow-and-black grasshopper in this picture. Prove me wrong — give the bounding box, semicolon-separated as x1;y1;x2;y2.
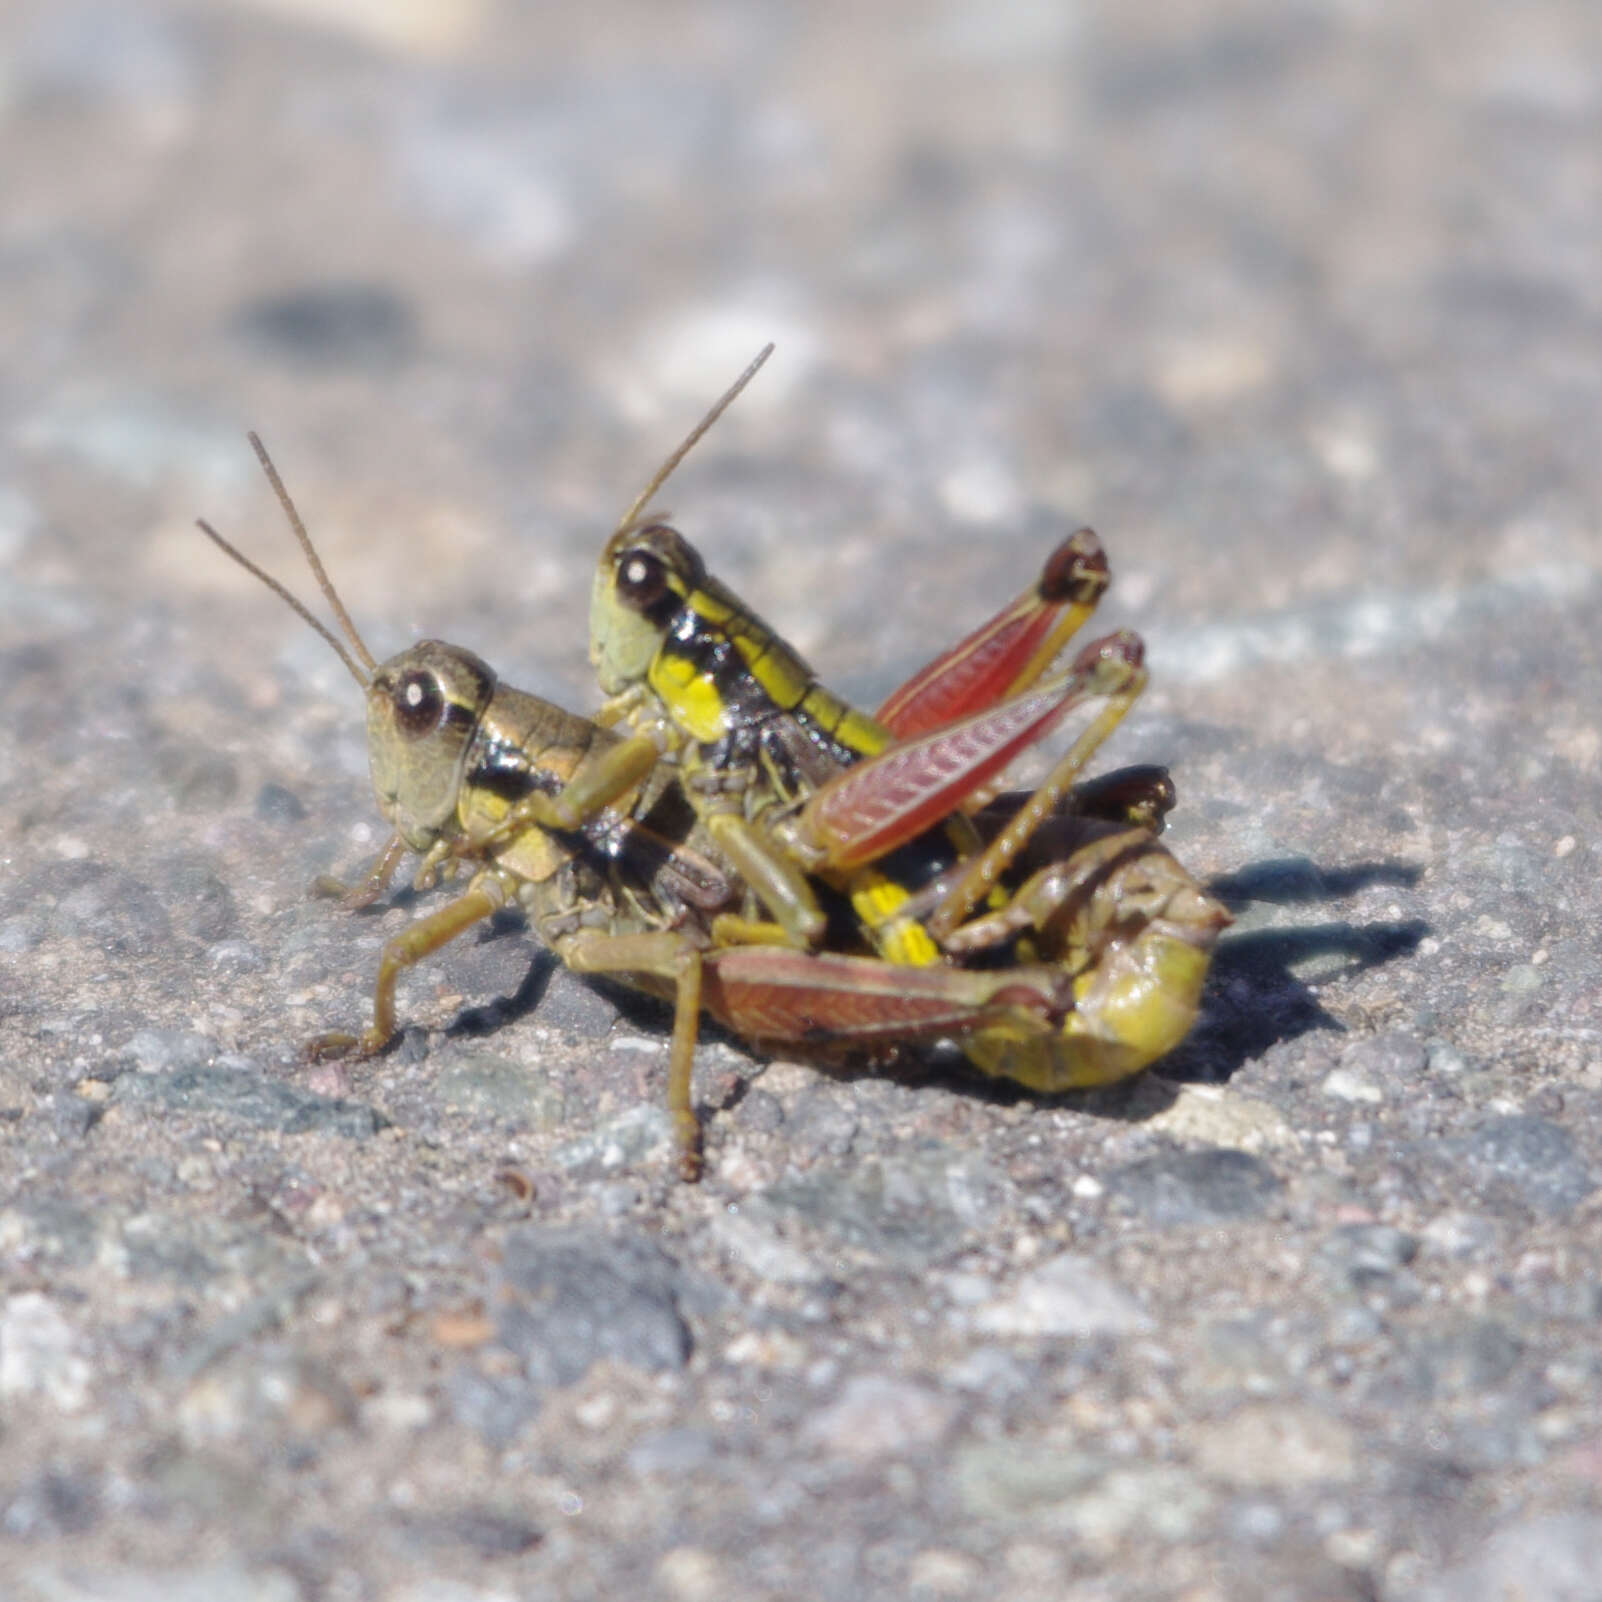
590;522;706;695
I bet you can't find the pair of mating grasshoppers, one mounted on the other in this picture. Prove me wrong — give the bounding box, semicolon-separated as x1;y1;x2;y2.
200;352;1227;1177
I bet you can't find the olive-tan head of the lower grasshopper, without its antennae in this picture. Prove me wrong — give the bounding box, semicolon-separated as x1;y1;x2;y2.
367;639;495;851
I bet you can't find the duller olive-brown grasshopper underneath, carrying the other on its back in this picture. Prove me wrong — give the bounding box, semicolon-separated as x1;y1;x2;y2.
199;434;1204;1179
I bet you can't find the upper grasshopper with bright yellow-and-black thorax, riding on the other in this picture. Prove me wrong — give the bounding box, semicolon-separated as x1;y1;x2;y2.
487;348;1229;1089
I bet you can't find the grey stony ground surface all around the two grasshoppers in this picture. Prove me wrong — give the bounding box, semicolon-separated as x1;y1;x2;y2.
0;0;1602;1602
